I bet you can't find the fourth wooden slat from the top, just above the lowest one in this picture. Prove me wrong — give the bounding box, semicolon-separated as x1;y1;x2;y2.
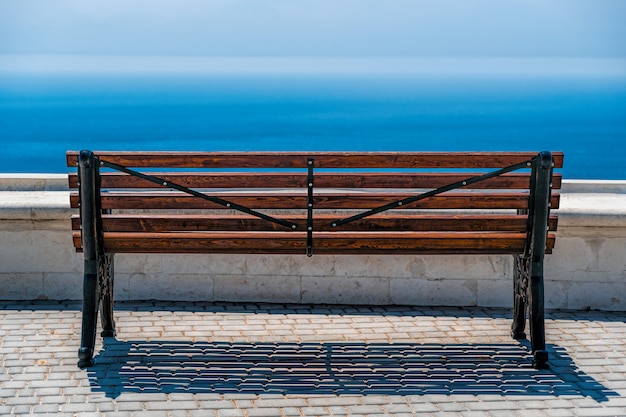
72;213;557;232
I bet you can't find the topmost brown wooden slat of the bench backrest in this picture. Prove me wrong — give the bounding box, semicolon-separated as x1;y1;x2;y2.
66;151;563;168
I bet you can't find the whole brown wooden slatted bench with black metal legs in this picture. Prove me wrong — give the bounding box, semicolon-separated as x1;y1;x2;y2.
67;151;563;368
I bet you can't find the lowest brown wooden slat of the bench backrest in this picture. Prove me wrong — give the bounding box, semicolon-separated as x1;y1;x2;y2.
74;232;554;254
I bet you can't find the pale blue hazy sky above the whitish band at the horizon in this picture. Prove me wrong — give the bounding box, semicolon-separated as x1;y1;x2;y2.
0;0;626;58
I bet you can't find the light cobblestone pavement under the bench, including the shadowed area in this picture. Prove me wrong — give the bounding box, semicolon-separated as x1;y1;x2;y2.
0;302;626;417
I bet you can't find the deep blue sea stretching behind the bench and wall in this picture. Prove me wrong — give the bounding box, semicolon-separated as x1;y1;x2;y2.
0;57;626;179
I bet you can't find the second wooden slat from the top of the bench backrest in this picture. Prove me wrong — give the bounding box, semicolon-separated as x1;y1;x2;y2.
69;172;561;189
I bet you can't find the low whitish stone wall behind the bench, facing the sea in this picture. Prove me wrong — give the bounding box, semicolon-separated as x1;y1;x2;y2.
0;174;626;311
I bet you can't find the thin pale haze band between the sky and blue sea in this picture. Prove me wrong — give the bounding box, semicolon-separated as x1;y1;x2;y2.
0;54;626;78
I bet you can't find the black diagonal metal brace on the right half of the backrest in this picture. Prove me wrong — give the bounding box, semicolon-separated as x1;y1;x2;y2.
331;157;536;227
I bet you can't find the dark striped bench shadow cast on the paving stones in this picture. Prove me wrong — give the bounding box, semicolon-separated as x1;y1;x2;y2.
87;338;618;402
